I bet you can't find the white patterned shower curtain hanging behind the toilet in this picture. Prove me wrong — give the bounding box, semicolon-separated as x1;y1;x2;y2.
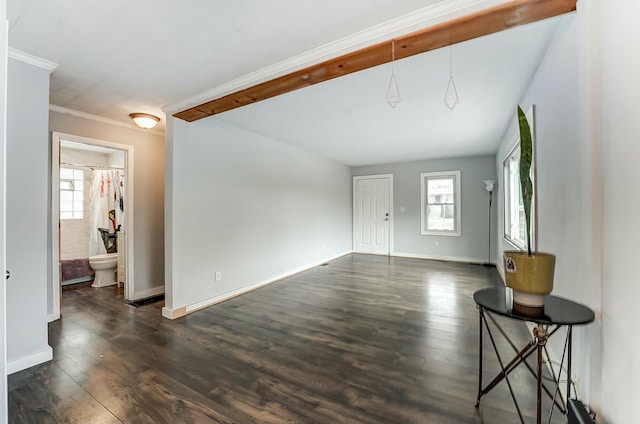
89;169;124;256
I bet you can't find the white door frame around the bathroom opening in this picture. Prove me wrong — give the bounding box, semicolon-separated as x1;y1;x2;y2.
49;131;135;322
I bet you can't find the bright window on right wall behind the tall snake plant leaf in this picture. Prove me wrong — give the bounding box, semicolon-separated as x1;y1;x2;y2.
503;142;535;250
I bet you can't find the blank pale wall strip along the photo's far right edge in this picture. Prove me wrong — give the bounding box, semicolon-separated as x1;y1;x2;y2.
593;0;640;423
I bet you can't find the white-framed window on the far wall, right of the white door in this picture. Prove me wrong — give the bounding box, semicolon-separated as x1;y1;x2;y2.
420;171;461;236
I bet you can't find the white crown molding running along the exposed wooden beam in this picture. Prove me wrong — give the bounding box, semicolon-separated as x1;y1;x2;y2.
162;0;513;115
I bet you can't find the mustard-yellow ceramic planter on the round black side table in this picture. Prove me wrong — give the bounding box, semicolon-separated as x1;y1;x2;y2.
503;251;556;306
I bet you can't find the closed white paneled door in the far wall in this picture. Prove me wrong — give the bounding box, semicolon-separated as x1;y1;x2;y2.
353;175;393;255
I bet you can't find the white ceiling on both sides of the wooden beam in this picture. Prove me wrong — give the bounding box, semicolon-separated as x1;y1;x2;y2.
8;0;558;165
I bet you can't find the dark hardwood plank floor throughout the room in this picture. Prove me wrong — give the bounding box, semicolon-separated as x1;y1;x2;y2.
9;255;565;424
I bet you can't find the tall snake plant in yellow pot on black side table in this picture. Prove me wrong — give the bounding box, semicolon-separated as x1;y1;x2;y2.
503;106;556;307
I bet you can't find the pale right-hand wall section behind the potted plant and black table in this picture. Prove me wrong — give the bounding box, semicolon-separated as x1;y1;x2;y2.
496;2;608;422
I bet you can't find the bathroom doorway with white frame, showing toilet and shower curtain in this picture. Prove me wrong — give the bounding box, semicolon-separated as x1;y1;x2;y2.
50;132;135;321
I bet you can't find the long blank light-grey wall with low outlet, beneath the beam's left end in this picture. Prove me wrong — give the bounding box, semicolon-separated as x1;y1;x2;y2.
164;118;351;317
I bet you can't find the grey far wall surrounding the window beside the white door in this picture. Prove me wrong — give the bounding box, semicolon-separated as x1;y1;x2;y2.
352;156;496;263
